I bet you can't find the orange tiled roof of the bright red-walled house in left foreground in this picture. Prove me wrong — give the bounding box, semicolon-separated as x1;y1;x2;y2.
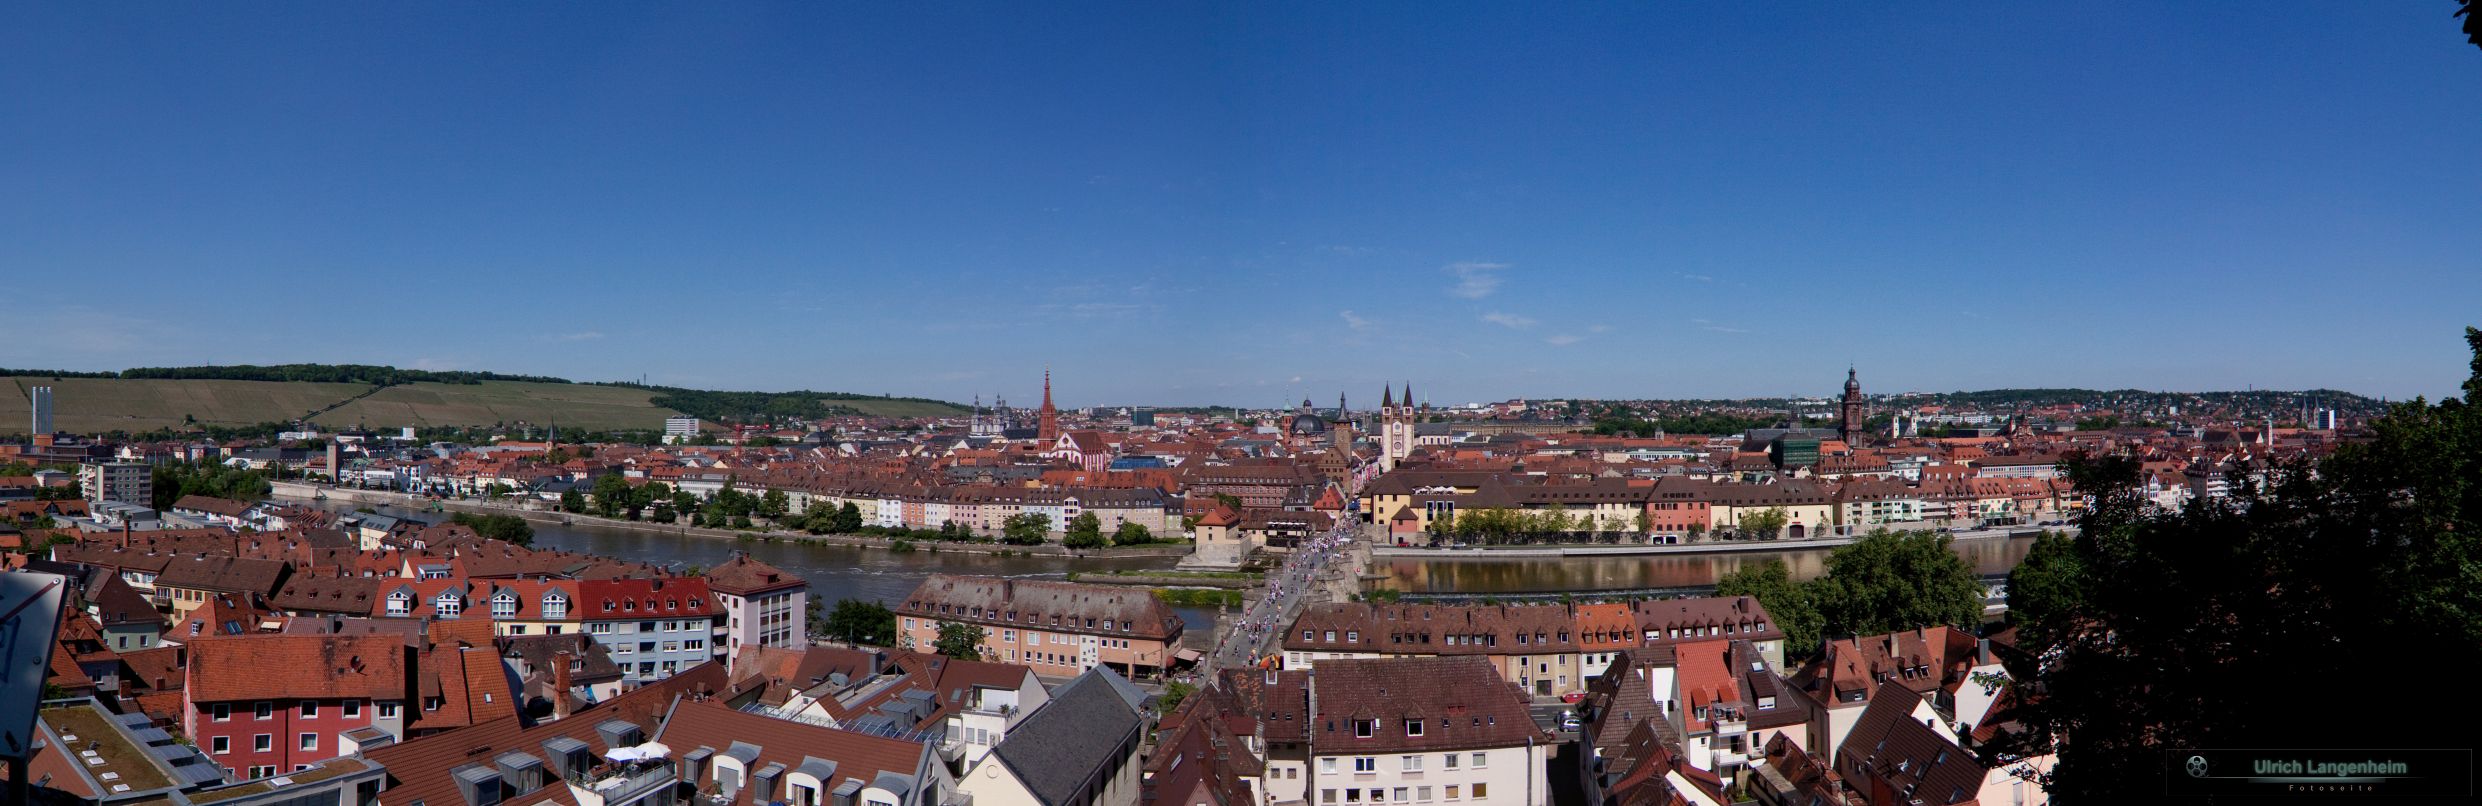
186;632;407;702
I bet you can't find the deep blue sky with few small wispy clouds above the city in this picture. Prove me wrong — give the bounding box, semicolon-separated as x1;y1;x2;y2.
0;0;2482;404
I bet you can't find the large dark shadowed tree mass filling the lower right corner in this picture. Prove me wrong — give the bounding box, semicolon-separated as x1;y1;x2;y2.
1988;327;2482;801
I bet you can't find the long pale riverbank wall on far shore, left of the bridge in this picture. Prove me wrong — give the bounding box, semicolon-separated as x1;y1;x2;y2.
273;481;1189;558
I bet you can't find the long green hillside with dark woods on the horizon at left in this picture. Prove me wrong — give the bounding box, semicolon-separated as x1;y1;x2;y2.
0;365;965;434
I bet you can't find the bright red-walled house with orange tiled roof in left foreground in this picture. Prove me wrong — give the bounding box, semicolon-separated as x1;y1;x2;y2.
181;632;412;779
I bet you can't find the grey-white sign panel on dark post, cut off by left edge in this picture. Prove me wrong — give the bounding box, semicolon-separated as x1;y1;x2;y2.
0;570;69;804
